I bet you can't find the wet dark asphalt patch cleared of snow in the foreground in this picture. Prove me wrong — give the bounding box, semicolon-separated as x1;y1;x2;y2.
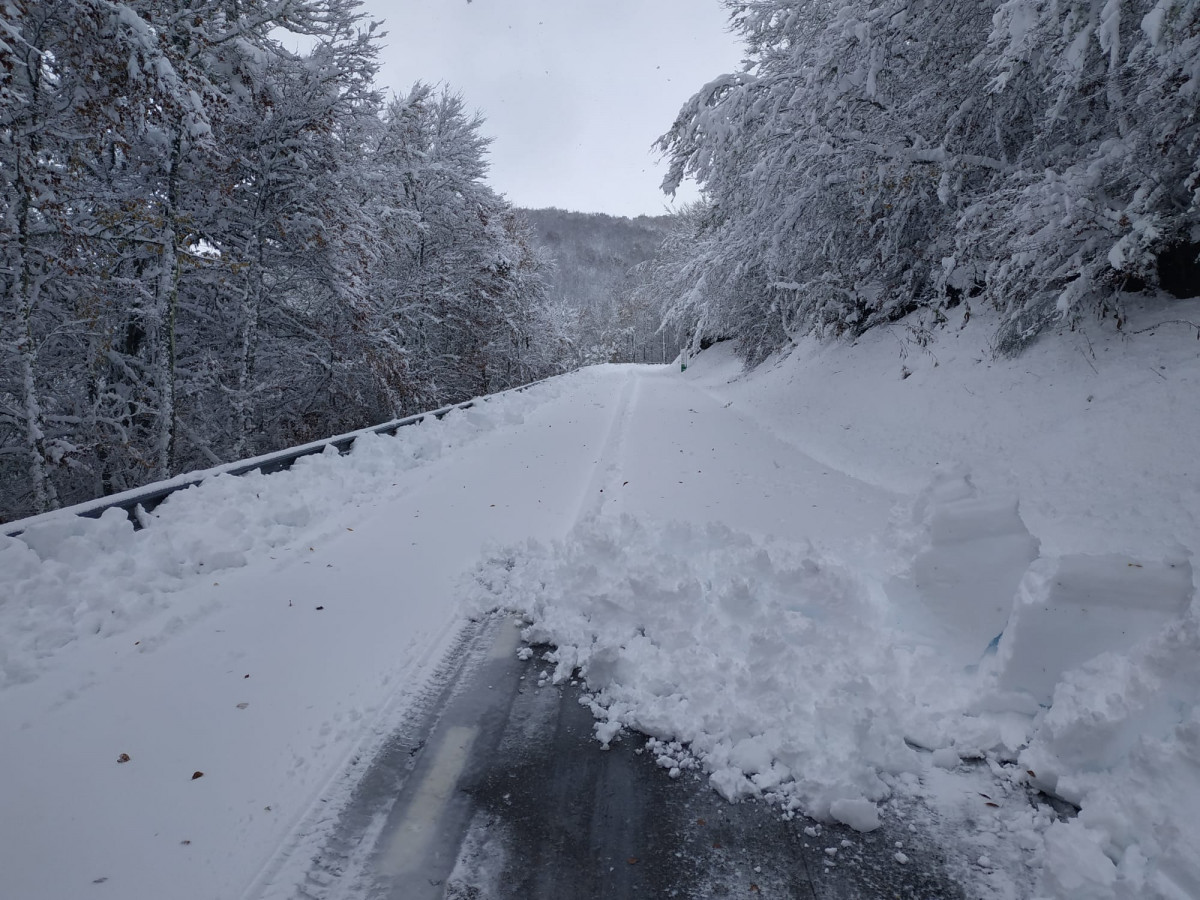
285;616;964;900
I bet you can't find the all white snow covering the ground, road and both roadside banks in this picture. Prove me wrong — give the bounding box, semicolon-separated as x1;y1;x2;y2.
0;301;1200;900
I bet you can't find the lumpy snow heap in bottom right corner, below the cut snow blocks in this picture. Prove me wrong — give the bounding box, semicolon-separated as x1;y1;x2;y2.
1021;611;1200;900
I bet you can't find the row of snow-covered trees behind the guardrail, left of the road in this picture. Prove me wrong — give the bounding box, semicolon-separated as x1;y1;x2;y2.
0;0;569;520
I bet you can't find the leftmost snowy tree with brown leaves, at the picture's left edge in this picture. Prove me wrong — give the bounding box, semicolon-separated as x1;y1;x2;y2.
0;0;184;509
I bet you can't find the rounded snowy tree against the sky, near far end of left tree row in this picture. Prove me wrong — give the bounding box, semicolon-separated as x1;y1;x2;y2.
367;84;556;406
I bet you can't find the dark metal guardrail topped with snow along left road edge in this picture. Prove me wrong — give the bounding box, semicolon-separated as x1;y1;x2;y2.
0;378;550;538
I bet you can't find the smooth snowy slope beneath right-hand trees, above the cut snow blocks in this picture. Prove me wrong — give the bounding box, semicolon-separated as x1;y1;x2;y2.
700;298;1200;559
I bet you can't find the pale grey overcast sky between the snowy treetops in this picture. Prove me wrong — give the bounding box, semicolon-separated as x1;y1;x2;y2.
365;0;740;216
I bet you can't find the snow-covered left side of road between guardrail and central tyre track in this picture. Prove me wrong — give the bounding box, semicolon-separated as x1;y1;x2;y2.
0;371;631;900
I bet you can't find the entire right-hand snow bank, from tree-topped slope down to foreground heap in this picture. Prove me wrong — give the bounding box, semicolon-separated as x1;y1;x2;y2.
689;307;1200;900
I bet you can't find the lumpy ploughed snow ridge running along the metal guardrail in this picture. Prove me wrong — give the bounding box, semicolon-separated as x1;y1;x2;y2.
0;386;537;689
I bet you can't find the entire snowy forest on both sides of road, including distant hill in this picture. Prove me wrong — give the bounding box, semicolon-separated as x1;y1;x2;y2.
0;0;1200;521
